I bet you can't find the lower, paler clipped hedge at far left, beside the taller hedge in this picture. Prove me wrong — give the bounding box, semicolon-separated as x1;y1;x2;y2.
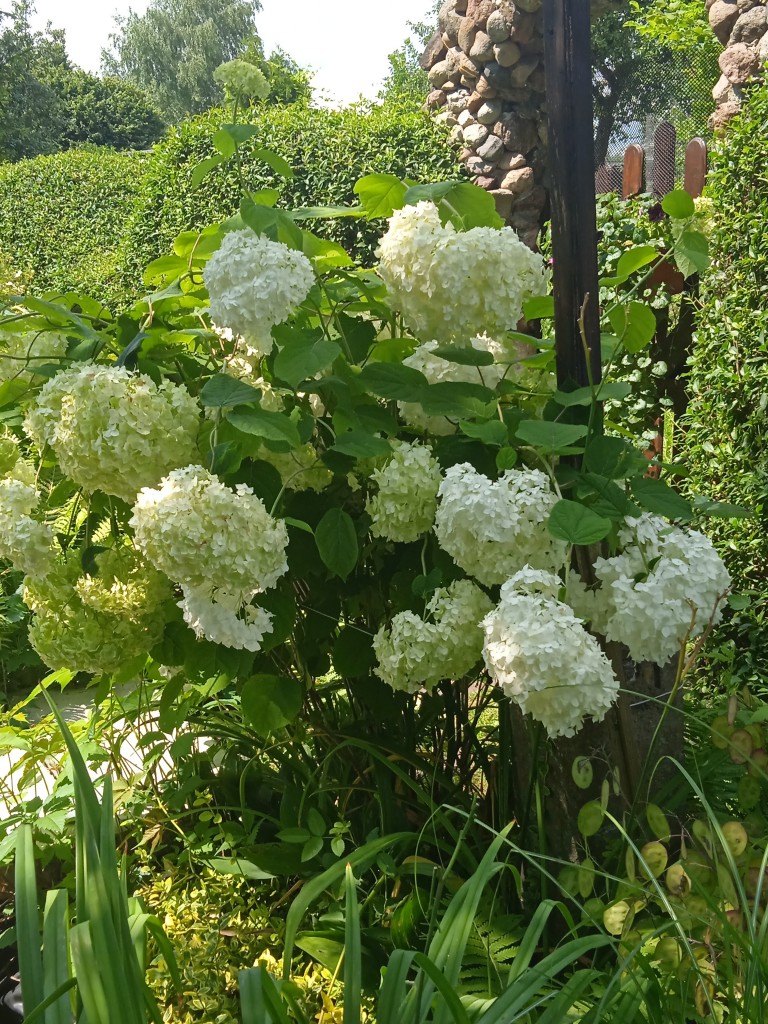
0;147;150;303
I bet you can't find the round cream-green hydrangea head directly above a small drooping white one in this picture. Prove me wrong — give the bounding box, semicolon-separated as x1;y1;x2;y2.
131;466;288;595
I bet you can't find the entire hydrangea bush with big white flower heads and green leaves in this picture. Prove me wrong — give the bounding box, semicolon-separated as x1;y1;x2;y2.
0;94;729;753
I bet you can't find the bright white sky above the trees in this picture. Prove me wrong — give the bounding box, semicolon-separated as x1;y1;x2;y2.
28;0;432;103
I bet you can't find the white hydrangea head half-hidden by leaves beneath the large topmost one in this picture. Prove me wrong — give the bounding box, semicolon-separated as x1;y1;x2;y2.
397;334;518;435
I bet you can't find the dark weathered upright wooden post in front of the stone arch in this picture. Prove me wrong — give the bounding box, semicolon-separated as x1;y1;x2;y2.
544;0;601;388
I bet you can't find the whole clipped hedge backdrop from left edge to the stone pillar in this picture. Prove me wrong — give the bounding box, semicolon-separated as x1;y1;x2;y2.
0;106;466;305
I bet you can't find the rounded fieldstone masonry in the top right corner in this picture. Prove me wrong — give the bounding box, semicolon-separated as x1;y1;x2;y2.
707;0;768;131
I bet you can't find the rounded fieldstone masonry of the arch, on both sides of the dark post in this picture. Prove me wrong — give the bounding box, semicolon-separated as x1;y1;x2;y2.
428;0;768;234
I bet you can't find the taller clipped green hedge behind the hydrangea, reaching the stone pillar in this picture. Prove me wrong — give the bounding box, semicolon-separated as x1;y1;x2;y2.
125;106;466;282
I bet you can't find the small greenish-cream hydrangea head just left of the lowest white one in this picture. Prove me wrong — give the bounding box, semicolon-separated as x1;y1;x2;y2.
374;580;493;693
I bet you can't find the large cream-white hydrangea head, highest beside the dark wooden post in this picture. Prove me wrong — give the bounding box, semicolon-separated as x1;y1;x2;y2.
378;203;546;342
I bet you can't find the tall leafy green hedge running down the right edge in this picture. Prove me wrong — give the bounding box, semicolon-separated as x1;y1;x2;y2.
683;86;768;683
